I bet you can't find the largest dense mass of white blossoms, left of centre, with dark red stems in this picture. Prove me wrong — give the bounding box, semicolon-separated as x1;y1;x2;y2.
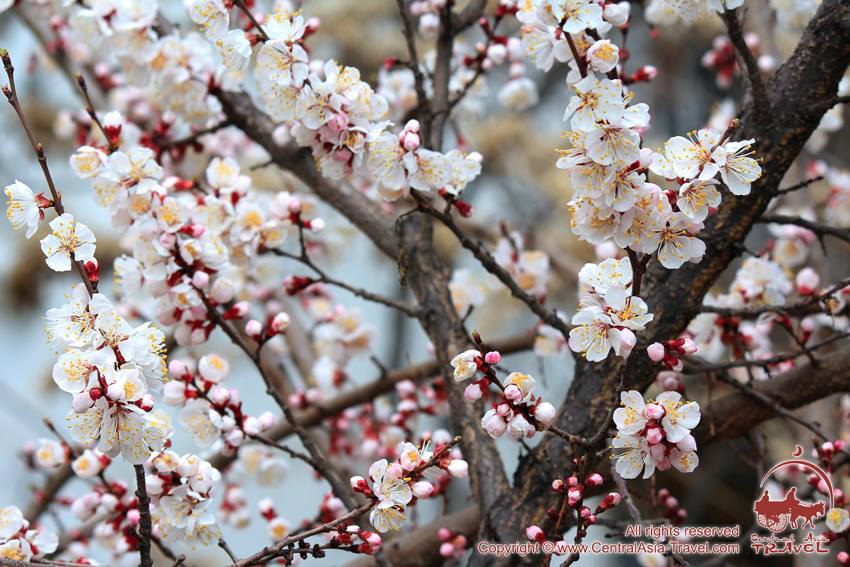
71;126;314;345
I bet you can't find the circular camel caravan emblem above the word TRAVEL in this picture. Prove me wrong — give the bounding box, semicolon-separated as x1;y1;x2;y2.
753;445;824;534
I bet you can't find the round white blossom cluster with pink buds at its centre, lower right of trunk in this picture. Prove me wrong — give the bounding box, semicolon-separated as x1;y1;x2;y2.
611;390;700;479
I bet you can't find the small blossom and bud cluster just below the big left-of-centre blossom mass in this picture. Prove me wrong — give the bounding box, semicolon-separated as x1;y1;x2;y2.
163;354;276;455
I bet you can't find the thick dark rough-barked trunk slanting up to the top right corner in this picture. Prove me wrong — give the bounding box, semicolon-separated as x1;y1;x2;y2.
474;0;850;565
